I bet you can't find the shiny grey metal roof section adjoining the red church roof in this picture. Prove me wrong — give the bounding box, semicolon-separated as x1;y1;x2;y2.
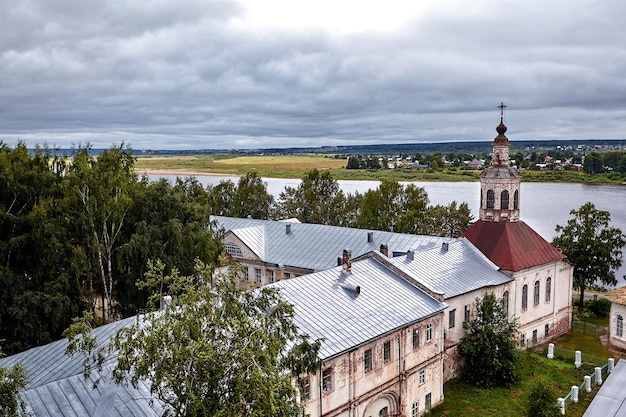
380;238;513;299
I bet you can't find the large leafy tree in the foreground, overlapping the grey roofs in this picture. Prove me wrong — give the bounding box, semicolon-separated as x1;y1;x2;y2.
67;262;321;417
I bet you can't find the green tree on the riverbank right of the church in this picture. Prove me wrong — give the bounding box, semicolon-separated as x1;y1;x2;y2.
552;202;626;310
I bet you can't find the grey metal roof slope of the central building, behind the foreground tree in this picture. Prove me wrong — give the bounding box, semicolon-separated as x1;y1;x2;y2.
271;258;447;359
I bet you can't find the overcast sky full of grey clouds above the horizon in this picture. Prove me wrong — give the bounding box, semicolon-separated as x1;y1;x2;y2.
0;0;626;150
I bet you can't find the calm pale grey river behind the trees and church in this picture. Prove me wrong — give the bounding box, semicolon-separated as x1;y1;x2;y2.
150;175;626;286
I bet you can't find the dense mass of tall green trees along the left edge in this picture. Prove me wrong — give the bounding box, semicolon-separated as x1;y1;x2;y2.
0;143;221;354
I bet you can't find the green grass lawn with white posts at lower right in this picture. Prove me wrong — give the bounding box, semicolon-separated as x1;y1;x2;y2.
430;332;618;417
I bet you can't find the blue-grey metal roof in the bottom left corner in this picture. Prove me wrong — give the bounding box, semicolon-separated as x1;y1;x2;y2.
0;317;163;417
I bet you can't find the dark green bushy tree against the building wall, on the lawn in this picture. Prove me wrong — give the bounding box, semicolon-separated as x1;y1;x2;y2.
459;293;519;388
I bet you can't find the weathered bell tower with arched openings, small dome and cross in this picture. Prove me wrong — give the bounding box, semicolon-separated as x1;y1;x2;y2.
479;103;522;222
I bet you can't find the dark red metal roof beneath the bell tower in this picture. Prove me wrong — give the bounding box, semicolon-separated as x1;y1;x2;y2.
463;220;565;272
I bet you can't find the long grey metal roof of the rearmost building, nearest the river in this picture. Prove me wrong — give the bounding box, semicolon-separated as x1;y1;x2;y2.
212;216;448;271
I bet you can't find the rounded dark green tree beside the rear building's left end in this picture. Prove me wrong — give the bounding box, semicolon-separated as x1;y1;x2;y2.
117;177;222;316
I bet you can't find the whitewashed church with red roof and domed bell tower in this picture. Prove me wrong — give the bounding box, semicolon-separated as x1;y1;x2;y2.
463;104;573;347
